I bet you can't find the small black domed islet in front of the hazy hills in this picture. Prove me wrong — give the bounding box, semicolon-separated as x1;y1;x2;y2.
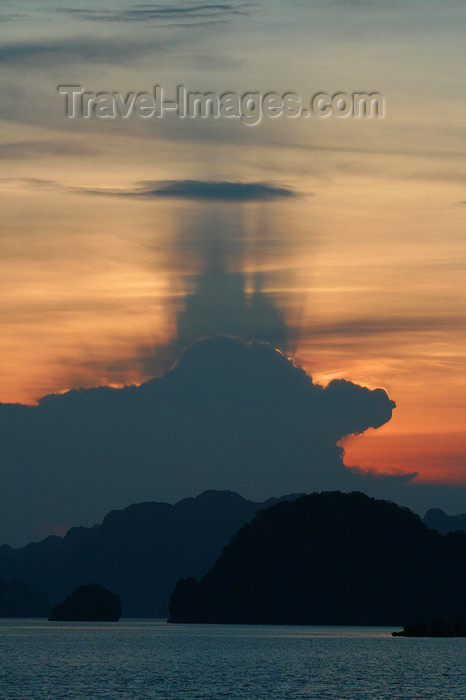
49;583;121;622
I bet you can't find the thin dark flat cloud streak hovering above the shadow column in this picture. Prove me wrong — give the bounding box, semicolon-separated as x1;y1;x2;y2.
78;180;296;202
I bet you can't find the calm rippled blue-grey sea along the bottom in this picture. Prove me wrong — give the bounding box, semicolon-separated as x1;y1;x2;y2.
0;620;466;700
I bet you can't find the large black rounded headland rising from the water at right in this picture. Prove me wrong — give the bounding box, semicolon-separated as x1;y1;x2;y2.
169;491;466;626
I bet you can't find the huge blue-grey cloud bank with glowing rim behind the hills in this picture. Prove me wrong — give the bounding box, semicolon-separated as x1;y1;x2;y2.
0;337;395;544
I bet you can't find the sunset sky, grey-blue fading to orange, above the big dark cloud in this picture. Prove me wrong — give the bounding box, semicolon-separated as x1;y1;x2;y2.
0;0;466;540
